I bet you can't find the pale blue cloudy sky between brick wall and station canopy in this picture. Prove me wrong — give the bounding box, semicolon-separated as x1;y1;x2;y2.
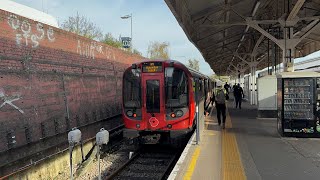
13;0;213;75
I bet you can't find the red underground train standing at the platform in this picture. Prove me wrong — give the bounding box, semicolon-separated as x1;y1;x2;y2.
122;60;215;144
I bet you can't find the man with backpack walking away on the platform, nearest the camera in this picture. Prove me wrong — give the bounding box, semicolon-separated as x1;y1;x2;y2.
213;81;229;129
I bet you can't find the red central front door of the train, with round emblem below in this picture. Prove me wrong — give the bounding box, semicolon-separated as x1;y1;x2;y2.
142;74;166;130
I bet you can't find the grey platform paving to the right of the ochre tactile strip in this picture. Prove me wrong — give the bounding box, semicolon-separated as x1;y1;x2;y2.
228;99;320;180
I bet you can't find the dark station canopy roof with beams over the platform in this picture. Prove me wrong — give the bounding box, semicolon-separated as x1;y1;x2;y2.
165;0;320;75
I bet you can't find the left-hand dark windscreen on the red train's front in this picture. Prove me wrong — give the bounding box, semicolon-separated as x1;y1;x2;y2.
123;69;141;108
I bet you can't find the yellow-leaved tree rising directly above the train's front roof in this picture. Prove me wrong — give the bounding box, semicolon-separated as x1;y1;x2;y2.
148;41;169;59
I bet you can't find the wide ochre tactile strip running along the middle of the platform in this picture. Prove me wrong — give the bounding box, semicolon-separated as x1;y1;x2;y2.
221;109;247;180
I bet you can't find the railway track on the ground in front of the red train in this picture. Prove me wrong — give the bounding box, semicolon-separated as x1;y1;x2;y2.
107;145;181;180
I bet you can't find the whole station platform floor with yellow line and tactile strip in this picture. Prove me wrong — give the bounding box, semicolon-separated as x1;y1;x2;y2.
168;99;320;180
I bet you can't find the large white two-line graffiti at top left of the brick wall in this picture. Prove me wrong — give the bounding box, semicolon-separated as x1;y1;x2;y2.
8;14;55;48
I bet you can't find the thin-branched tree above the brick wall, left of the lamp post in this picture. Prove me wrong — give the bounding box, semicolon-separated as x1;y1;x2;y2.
61;13;102;40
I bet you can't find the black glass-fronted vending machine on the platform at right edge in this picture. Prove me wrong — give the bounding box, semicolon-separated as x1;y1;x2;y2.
277;72;320;137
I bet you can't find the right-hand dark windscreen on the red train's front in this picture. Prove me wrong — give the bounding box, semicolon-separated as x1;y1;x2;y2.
165;68;188;108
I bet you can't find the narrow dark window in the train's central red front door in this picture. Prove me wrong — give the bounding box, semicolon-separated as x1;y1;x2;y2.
146;80;160;113
